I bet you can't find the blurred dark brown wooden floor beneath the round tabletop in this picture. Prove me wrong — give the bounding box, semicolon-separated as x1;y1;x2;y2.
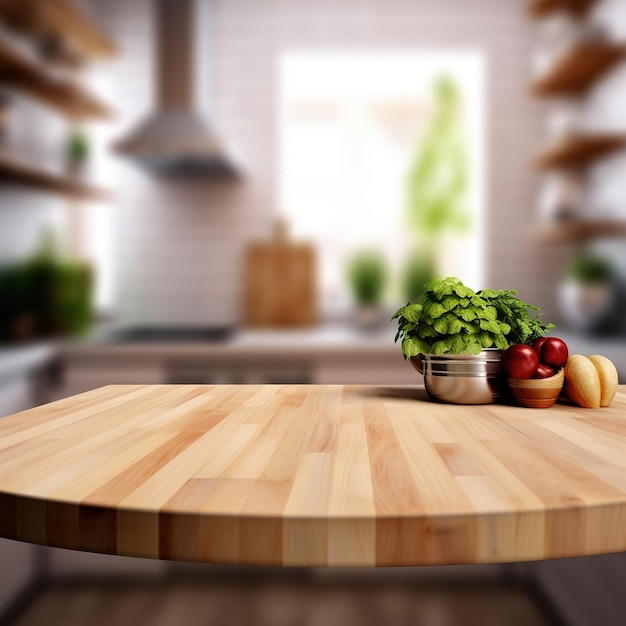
10;580;556;626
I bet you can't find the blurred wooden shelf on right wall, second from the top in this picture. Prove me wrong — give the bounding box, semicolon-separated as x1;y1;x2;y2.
532;42;626;96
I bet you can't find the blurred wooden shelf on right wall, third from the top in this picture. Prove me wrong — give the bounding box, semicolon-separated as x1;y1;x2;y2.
534;133;626;170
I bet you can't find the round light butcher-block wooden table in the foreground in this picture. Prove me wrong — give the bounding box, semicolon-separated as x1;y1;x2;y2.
0;385;626;566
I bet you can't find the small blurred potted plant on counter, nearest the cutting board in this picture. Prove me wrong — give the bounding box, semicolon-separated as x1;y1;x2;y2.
347;250;389;330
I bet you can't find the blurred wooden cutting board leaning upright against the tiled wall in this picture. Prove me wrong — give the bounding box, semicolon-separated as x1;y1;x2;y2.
244;226;317;328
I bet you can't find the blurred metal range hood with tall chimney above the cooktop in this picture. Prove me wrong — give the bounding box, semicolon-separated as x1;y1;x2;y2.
113;0;240;176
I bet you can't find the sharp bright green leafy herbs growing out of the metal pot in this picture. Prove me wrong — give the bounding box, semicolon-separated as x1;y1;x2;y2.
392;276;554;359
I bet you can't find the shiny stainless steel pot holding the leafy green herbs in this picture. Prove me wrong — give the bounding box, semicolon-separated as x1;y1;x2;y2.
411;348;506;404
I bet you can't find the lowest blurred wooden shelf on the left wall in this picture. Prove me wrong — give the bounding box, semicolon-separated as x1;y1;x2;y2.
0;151;110;201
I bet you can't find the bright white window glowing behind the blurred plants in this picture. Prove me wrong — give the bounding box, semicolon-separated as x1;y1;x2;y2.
279;51;485;312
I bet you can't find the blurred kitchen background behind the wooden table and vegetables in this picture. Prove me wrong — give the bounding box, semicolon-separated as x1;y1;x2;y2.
0;0;626;625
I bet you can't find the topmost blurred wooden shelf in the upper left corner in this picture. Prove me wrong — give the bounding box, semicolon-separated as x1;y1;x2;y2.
0;0;117;58
